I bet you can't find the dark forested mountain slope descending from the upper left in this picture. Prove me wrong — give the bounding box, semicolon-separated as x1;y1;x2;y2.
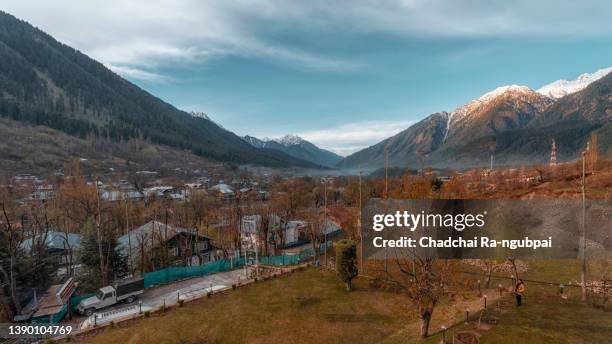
0;12;318;173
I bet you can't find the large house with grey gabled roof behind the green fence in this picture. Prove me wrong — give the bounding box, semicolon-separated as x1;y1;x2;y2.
118;221;215;266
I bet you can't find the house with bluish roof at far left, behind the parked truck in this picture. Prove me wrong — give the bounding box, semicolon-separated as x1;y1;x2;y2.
21;230;82;276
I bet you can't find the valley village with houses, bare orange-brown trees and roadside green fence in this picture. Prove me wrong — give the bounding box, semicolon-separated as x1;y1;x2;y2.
0;133;612;342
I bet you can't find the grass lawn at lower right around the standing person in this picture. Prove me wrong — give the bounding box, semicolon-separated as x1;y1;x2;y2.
425;260;612;344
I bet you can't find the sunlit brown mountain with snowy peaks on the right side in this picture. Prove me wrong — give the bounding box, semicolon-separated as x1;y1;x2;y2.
336;68;612;169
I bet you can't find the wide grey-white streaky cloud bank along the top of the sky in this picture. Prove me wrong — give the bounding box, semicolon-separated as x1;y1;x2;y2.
3;0;612;80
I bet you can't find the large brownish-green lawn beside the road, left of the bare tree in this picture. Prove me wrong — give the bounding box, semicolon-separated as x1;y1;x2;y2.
76;269;417;343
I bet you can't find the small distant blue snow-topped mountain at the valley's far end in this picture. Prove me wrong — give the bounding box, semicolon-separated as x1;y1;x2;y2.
242;135;342;167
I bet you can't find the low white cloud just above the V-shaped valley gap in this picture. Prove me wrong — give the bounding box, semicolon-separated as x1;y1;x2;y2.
298;120;414;156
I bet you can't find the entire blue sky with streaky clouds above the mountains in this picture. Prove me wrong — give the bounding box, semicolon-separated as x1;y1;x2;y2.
0;0;612;155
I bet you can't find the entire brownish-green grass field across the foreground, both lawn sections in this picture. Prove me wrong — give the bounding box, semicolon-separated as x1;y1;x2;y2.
79;262;612;344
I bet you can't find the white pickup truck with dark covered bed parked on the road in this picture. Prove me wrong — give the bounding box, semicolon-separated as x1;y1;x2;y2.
77;277;144;316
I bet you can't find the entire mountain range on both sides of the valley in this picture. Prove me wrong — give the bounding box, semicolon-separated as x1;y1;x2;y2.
0;12;612;175
